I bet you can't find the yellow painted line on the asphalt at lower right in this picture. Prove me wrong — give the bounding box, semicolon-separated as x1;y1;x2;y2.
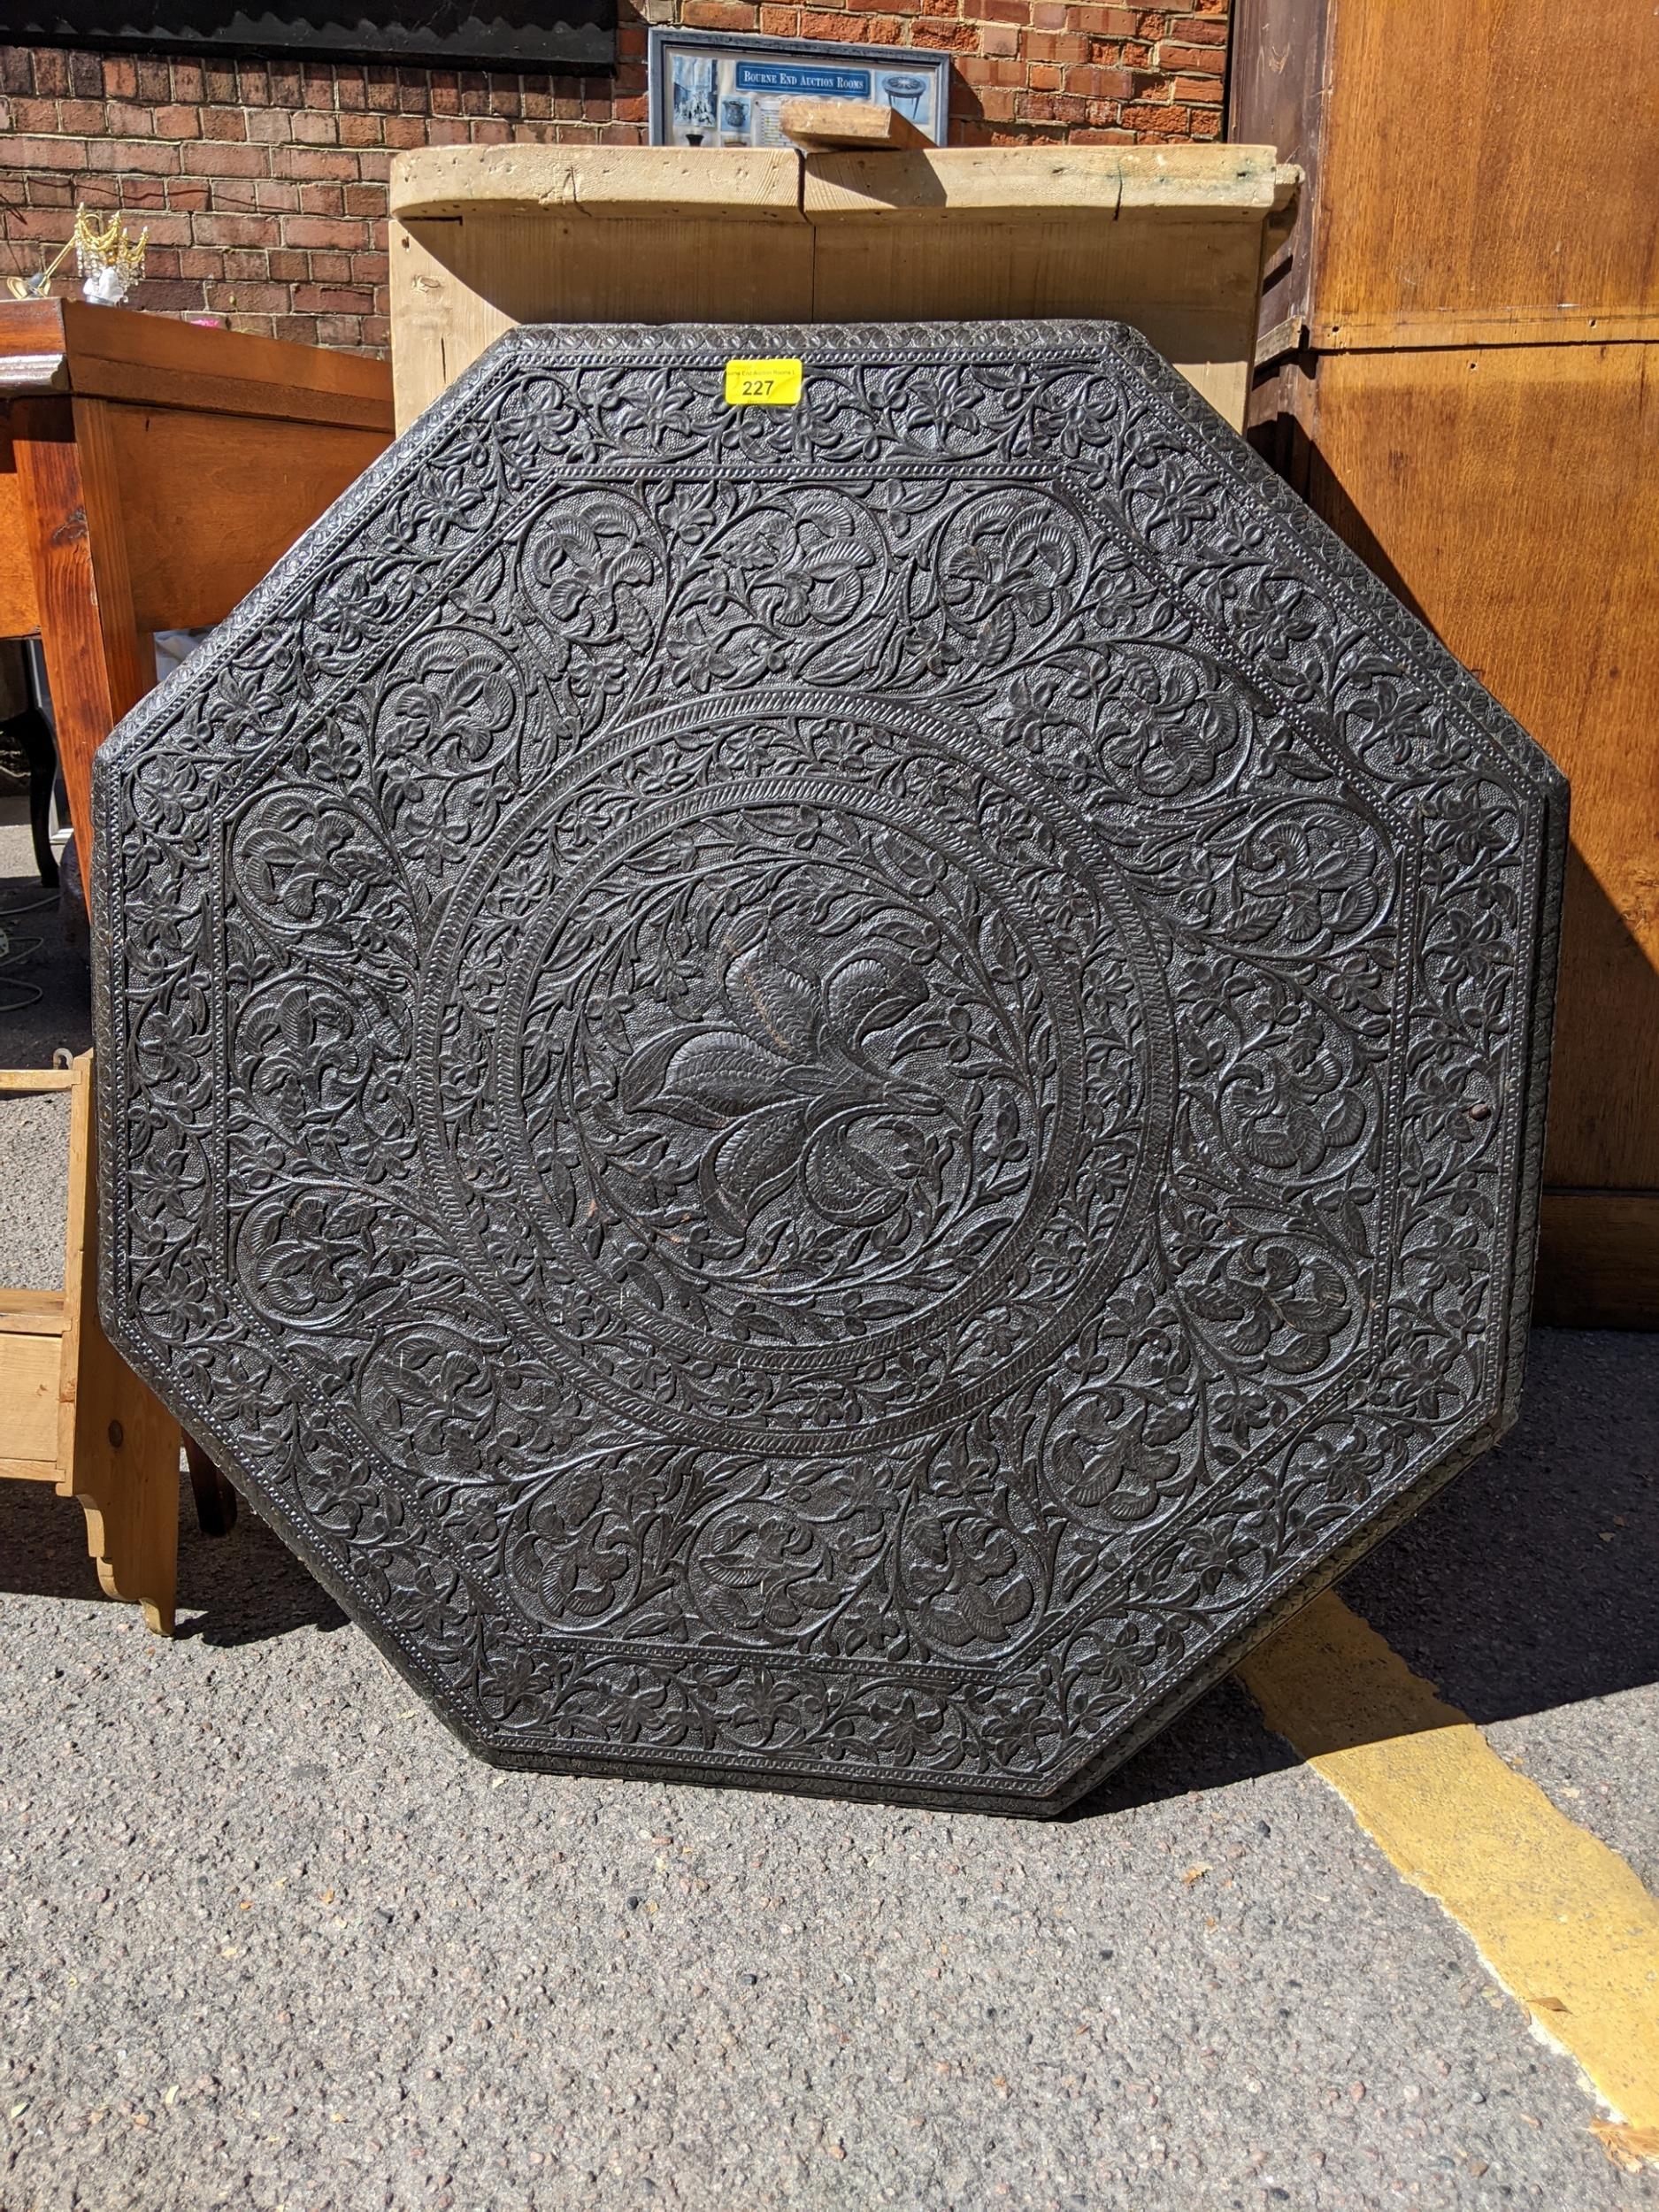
1239;1593;1659;2168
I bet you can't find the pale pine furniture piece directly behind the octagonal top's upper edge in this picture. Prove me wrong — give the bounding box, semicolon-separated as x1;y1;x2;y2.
389;144;1290;429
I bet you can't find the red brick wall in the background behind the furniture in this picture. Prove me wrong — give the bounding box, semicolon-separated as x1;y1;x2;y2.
0;0;1228;349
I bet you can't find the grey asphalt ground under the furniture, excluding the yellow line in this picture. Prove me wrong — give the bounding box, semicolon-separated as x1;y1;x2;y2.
0;827;1659;2212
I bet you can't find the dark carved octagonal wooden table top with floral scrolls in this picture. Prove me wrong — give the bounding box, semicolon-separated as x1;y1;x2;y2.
97;323;1566;1812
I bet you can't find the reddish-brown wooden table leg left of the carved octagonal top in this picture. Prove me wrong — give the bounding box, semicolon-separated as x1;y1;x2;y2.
12;398;155;849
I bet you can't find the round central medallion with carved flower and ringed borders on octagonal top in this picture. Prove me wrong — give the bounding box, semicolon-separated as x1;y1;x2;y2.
423;690;1172;1455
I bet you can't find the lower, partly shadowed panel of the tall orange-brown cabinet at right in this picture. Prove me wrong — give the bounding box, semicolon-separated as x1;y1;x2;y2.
1305;345;1659;1188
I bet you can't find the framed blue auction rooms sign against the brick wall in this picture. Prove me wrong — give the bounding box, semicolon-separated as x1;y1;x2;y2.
650;29;951;146
